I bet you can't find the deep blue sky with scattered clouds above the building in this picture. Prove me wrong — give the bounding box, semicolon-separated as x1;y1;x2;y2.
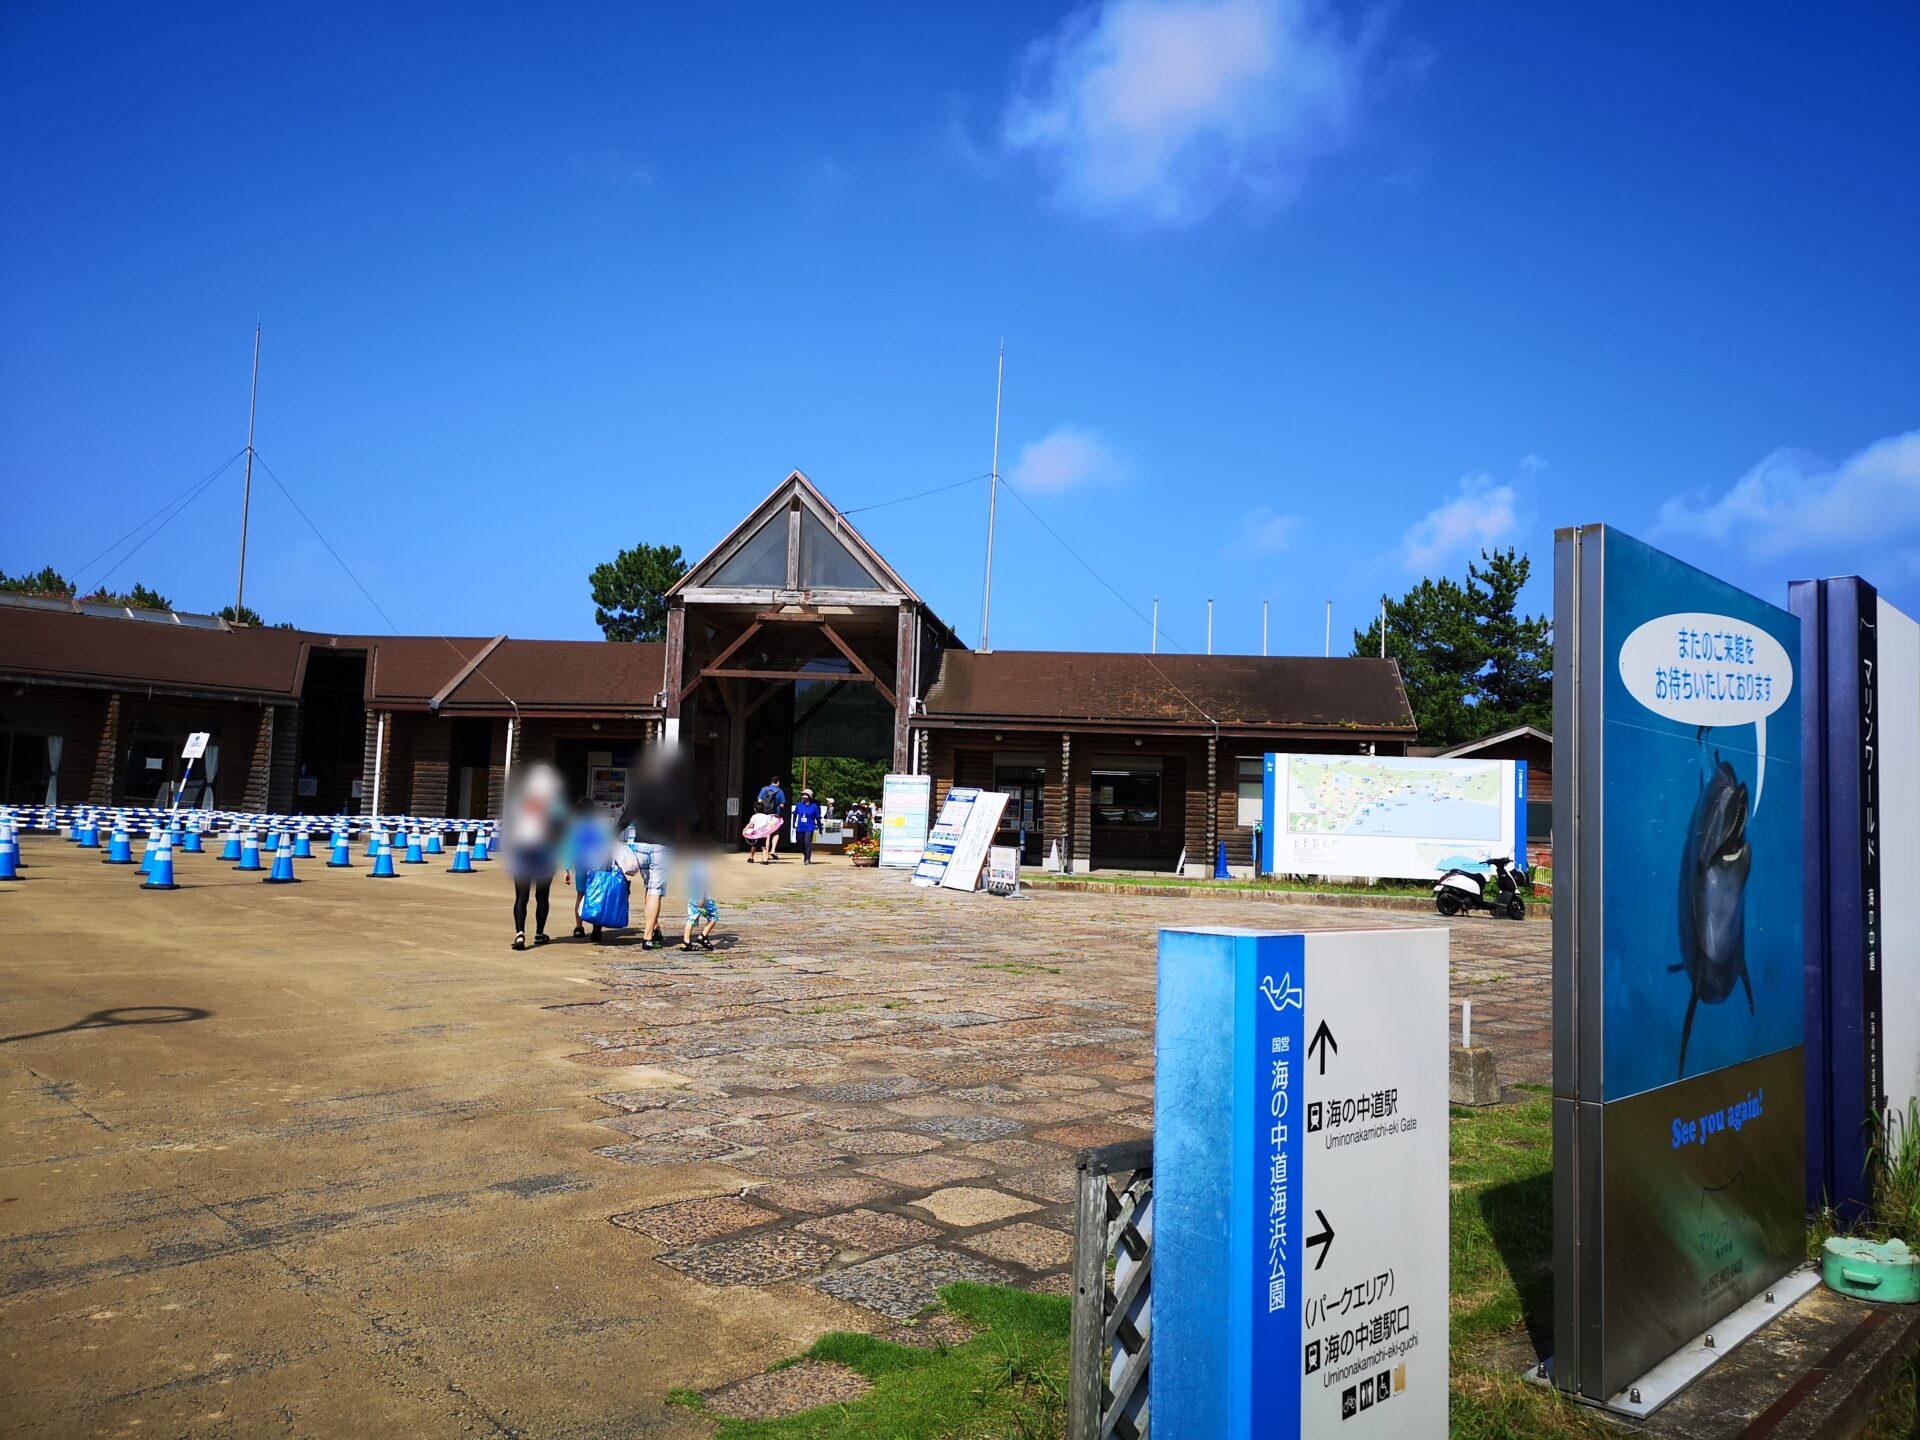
0;0;1920;653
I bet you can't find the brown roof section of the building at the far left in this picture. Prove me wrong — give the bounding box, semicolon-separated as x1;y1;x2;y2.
0;605;311;699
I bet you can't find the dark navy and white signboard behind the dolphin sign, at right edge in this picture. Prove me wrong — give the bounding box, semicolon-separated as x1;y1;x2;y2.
1789;576;1920;1223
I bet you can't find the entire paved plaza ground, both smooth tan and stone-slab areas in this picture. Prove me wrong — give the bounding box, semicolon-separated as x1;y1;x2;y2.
0;835;1549;1440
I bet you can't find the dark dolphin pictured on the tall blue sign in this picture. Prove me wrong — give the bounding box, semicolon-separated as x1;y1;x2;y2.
1667;755;1753;1077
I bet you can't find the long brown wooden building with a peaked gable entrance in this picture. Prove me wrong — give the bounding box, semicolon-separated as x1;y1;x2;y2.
0;470;1413;870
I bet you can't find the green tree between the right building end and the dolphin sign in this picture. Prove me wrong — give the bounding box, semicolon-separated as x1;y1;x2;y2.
1352;547;1553;745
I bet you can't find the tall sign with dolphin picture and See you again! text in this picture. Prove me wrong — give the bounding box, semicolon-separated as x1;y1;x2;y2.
1553;526;1805;1402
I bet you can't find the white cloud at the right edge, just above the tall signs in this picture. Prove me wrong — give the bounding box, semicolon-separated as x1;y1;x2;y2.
1653;430;1920;568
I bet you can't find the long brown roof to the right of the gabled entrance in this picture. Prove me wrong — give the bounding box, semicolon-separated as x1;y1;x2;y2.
925;651;1413;733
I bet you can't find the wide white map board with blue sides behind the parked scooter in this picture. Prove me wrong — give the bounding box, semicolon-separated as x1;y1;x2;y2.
1261;755;1526;879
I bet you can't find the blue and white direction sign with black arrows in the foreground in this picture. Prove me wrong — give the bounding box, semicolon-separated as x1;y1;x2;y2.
1150;929;1448;1440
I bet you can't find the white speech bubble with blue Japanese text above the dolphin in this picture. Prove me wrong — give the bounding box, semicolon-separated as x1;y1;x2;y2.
1620;611;1793;812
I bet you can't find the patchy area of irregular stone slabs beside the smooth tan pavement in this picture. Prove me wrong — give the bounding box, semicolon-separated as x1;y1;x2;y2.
566;864;1551;1321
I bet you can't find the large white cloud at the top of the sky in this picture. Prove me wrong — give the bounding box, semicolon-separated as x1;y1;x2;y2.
1002;0;1365;225
